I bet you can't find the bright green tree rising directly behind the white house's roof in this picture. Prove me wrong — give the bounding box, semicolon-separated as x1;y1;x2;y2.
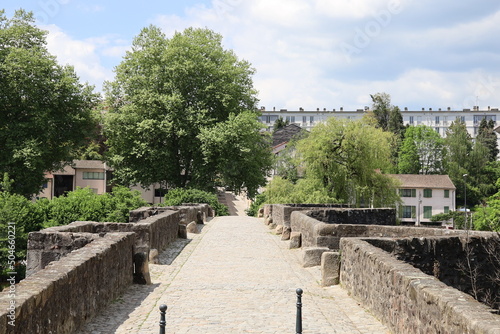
398;125;444;174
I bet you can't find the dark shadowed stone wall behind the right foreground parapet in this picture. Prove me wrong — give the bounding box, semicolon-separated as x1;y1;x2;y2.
365;232;500;309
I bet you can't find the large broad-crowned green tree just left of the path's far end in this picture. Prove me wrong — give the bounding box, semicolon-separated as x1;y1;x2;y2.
105;26;269;196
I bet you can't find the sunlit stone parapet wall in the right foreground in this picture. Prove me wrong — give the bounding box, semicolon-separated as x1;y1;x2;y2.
340;237;500;334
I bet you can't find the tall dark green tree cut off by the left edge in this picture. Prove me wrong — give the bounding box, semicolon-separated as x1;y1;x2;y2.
0;10;98;197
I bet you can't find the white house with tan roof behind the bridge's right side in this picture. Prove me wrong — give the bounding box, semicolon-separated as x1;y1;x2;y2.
389;174;456;225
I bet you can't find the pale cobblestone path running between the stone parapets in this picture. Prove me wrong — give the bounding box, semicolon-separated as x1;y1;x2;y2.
78;216;390;334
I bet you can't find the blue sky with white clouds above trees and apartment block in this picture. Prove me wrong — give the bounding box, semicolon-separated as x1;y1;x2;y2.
0;0;500;110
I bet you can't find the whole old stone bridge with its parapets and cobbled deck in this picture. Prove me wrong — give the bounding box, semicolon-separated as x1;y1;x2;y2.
0;194;500;334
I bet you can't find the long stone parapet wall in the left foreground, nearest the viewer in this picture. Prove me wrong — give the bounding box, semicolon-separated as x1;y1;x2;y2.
0;233;135;334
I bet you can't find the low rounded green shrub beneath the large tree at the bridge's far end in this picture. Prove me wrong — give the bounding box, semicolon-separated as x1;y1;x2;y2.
163;188;229;216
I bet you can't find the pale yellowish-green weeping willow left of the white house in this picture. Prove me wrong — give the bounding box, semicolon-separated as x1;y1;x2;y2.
297;117;399;207
